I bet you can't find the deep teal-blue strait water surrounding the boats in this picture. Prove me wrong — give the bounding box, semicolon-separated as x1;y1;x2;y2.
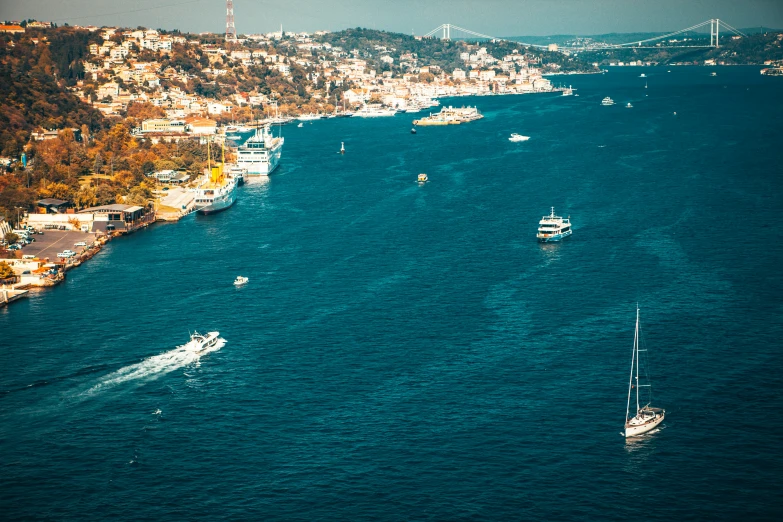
0;67;783;521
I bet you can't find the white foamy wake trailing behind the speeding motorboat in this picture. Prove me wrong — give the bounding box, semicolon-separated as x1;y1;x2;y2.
80;339;226;396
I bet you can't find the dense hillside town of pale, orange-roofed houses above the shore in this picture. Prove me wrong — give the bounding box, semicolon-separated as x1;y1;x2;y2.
0;25;568;139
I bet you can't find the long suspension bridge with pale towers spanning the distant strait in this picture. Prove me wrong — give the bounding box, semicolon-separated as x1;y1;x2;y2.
424;18;747;51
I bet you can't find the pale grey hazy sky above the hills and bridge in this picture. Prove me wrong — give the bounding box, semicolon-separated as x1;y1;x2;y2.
0;0;783;36
